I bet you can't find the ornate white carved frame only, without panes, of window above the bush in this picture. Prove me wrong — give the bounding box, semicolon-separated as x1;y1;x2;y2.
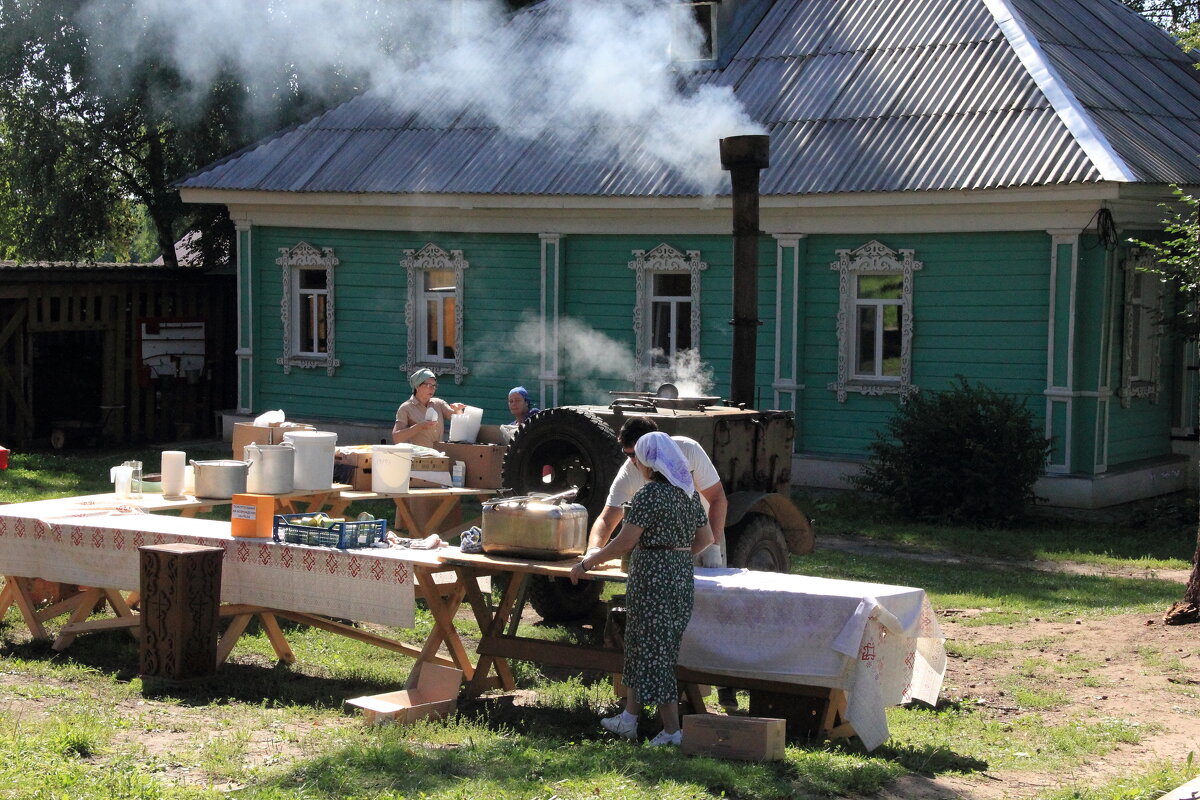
827;240;924;403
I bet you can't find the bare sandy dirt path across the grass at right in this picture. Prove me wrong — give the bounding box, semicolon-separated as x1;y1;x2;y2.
821;536;1200;800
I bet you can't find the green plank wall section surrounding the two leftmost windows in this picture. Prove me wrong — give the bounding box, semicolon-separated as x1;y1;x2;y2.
252;228;541;423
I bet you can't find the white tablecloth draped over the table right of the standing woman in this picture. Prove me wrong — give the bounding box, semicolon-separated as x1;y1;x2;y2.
679;570;946;750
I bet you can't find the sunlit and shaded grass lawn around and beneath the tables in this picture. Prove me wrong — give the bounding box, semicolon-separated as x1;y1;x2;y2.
0;444;1200;800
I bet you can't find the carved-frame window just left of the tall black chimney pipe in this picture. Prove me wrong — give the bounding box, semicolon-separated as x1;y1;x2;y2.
629;243;708;383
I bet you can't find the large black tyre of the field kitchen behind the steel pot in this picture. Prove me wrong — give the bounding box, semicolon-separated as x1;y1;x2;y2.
502;408;622;524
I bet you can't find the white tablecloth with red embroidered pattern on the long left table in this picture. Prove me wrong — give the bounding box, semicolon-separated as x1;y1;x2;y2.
0;498;417;627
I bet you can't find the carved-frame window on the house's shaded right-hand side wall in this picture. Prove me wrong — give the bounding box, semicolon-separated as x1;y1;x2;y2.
1117;247;1166;408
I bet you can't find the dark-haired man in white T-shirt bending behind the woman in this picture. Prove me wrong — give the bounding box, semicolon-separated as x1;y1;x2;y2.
588;416;728;566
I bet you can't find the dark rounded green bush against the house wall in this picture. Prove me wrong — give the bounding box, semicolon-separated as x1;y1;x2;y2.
851;377;1050;527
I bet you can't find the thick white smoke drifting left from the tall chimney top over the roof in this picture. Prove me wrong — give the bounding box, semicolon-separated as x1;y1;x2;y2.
82;0;762;193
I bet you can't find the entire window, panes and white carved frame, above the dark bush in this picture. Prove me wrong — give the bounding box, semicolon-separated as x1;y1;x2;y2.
828;241;922;403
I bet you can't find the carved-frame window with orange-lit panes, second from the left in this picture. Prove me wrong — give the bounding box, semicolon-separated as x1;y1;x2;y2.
401;242;470;384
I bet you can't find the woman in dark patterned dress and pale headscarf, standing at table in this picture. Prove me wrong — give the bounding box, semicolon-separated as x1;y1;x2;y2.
571;431;713;746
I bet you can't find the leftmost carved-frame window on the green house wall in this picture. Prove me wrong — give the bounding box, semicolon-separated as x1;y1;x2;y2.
275;242;342;375
